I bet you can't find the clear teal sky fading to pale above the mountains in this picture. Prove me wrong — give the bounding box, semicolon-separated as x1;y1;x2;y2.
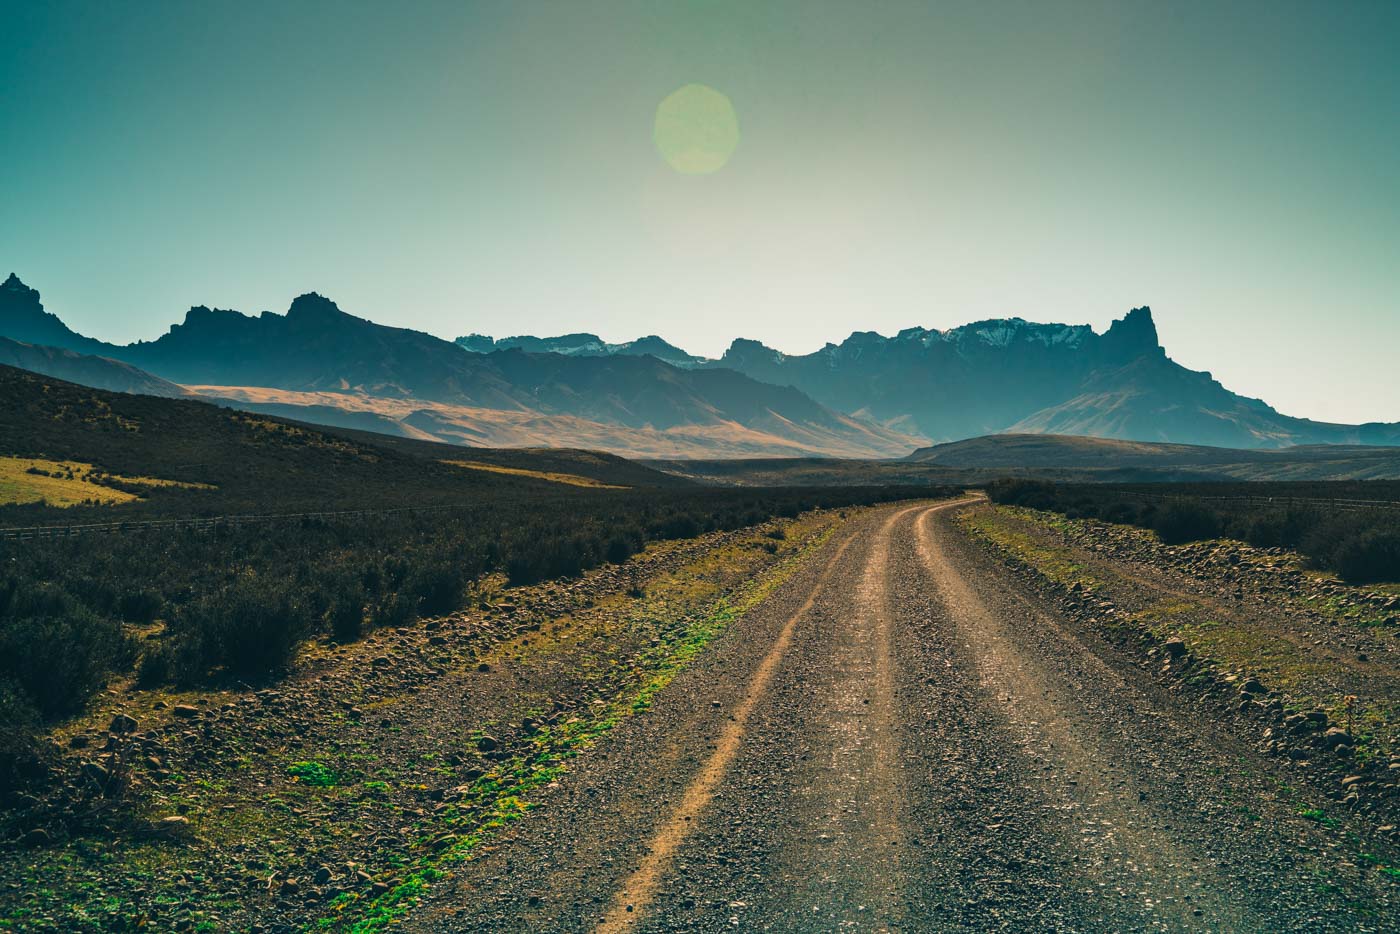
0;0;1400;421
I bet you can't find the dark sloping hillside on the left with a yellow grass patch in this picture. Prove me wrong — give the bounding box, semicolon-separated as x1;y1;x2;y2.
0;367;680;525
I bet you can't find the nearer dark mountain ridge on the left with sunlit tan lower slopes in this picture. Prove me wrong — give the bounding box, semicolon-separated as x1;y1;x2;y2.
0;274;918;456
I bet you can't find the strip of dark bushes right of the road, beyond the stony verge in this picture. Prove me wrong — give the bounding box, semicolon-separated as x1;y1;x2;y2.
987;480;1400;584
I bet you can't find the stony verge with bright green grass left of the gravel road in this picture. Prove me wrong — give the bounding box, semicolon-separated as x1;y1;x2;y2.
0;511;847;931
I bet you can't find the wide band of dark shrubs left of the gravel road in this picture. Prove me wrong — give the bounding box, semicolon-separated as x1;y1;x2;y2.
0;485;927;795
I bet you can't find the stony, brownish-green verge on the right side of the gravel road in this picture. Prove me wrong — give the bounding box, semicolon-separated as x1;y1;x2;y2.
962;507;1400;845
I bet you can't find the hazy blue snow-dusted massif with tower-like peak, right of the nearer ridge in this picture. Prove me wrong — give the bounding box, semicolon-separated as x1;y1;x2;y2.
464;307;1400;448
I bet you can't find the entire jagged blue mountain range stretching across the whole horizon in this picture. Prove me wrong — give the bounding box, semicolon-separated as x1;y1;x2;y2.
0;274;1400;458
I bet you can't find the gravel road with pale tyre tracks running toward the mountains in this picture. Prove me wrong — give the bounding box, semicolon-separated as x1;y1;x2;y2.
405;504;1400;931
